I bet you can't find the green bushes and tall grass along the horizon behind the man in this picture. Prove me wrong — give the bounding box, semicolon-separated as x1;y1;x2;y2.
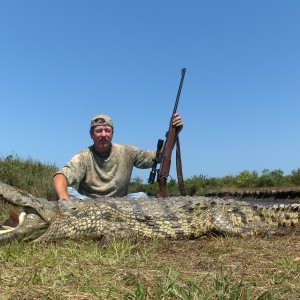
0;155;300;200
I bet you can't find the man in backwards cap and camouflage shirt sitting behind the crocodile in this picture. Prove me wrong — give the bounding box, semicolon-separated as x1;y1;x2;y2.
53;114;183;200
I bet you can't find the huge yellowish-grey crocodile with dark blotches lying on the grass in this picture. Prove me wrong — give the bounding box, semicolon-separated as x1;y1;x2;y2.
0;183;300;244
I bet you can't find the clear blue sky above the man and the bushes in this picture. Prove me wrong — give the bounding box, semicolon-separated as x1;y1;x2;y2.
0;0;300;180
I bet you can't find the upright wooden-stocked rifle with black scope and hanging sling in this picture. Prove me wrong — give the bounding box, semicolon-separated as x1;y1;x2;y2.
148;68;186;198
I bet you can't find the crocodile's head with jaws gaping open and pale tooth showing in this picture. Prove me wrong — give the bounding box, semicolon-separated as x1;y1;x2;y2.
0;183;55;244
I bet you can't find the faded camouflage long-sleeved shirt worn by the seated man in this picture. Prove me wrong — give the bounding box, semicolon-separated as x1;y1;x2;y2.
54;144;155;197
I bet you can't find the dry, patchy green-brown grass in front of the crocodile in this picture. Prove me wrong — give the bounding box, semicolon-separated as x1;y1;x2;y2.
0;225;300;300
